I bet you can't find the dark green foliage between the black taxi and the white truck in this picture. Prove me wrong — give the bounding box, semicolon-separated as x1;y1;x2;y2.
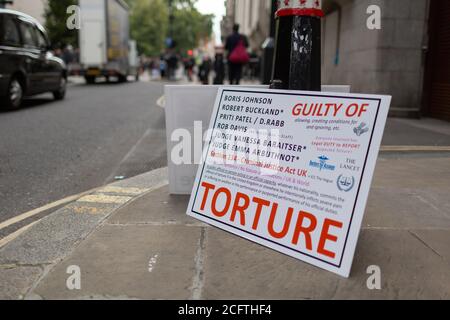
44;0;78;48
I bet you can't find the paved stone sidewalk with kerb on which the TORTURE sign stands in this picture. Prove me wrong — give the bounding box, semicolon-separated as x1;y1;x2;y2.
0;153;450;299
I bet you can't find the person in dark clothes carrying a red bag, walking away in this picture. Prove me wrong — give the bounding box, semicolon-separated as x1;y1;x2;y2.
225;24;250;84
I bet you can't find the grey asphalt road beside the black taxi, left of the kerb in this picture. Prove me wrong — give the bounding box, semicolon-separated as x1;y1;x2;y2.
0;82;167;222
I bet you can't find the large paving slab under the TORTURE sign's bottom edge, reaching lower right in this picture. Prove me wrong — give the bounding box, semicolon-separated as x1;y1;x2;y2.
202;228;450;299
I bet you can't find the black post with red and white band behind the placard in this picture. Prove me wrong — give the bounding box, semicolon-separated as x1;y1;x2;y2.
271;0;323;91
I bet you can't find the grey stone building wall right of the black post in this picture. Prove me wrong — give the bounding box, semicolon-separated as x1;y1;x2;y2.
322;0;429;116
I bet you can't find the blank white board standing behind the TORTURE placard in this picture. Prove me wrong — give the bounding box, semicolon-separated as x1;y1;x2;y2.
164;85;350;194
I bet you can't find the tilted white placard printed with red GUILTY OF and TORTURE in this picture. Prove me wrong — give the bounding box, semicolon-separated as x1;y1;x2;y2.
187;87;391;277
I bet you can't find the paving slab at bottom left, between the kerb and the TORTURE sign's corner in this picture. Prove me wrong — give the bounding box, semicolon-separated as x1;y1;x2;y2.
33;225;201;299
